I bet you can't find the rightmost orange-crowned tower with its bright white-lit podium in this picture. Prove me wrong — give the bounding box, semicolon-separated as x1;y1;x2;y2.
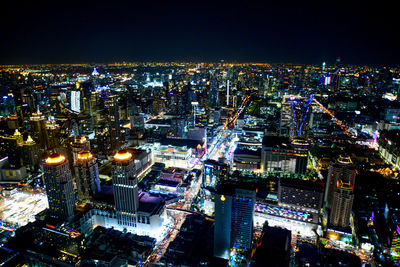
80;149;165;239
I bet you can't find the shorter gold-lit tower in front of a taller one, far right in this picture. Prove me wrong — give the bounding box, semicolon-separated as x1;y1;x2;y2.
329;177;354;228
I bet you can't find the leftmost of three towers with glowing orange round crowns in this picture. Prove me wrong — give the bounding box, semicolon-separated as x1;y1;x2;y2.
44;153;75;220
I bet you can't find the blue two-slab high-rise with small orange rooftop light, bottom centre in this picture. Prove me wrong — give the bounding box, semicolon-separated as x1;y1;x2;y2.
214;185;256;259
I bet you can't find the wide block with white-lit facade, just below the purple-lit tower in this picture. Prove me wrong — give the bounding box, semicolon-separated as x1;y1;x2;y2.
261;136;308;174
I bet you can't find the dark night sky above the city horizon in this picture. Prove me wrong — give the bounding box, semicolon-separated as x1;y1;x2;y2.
0;0;400;65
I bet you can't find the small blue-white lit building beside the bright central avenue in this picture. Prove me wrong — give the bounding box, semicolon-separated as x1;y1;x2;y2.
203;160;229;187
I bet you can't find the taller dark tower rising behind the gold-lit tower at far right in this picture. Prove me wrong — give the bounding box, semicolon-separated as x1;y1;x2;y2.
324;155;357;208
